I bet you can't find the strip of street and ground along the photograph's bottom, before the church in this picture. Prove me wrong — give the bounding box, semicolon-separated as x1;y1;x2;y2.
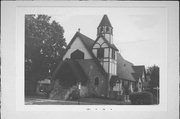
25;97;130;105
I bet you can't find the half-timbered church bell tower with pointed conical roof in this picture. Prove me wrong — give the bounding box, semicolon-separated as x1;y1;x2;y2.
92;15;118;96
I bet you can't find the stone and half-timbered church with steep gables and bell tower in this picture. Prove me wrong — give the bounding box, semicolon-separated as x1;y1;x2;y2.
53;15;146;97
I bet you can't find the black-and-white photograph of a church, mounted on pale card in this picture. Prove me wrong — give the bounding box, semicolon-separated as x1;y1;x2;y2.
24;8;162;105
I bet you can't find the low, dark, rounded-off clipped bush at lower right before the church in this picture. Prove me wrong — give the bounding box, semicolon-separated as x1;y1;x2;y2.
129;92;153;105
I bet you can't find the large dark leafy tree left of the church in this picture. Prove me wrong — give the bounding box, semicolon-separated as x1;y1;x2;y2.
25;15;67;95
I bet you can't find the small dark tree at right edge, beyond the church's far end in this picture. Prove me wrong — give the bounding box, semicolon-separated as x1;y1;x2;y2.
147;65;159;88
